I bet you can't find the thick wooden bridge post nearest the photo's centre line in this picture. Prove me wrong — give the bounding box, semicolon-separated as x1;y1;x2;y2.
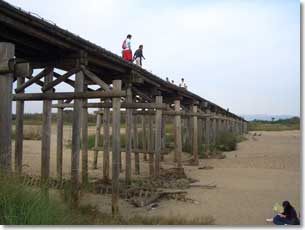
155;96;162;177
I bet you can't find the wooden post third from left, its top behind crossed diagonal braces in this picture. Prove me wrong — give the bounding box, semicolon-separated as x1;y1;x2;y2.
41;67;53;189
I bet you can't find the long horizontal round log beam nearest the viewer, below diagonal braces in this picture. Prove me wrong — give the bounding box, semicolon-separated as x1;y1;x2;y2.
13;91;126;101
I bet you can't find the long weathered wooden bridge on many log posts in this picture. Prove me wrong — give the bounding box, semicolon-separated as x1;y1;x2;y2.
0;0;247;215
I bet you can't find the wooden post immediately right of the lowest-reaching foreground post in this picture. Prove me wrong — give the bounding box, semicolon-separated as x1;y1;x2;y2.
125;87;133;184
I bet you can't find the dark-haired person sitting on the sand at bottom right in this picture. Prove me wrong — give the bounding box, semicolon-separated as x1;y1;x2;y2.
266;201;300;225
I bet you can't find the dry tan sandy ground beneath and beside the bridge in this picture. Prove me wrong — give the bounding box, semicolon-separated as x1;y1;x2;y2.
13;126;301;225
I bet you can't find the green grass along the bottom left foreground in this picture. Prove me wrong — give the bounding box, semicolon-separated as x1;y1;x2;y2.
0;174;214;225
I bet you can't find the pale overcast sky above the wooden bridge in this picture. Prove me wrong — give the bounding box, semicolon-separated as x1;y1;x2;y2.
9;0;300;115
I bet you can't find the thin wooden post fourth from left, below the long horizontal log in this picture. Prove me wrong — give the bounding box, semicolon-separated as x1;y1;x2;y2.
56;100;64;181
